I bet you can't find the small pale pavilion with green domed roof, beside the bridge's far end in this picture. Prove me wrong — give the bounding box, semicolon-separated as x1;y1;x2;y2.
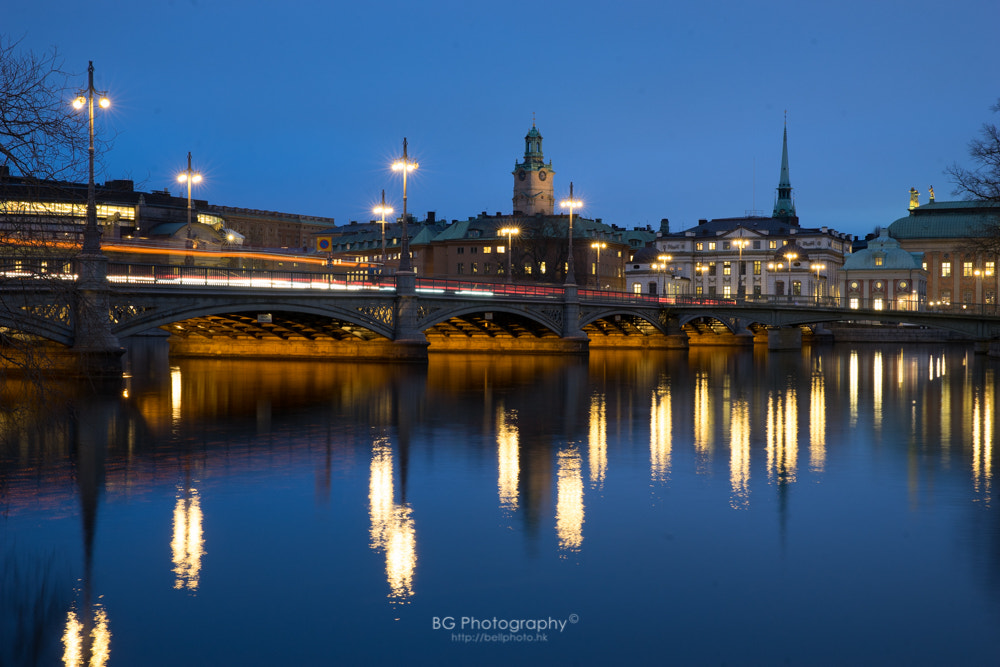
840;229;927;310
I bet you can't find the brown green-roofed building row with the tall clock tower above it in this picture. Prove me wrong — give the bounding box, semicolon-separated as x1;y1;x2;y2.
312;124;655;290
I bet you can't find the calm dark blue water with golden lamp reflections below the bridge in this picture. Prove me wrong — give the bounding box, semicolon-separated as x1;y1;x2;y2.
0;346;1000;667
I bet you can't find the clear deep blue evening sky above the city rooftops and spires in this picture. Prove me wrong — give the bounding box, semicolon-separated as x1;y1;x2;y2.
7;0;1000;240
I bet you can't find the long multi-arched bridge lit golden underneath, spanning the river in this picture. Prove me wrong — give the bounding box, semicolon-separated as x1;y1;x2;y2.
0;258;1000;370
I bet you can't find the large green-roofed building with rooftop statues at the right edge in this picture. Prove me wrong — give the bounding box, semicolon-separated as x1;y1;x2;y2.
889;188;1000;308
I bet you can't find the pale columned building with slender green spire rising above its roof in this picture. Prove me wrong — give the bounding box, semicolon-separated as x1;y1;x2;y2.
628;128;851;299
